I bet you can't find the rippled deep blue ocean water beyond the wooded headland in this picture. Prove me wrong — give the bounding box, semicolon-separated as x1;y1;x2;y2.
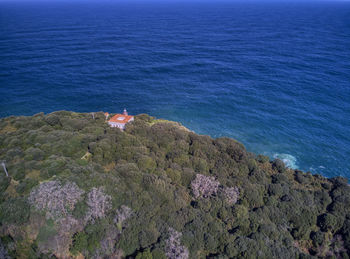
0;2;350;180
